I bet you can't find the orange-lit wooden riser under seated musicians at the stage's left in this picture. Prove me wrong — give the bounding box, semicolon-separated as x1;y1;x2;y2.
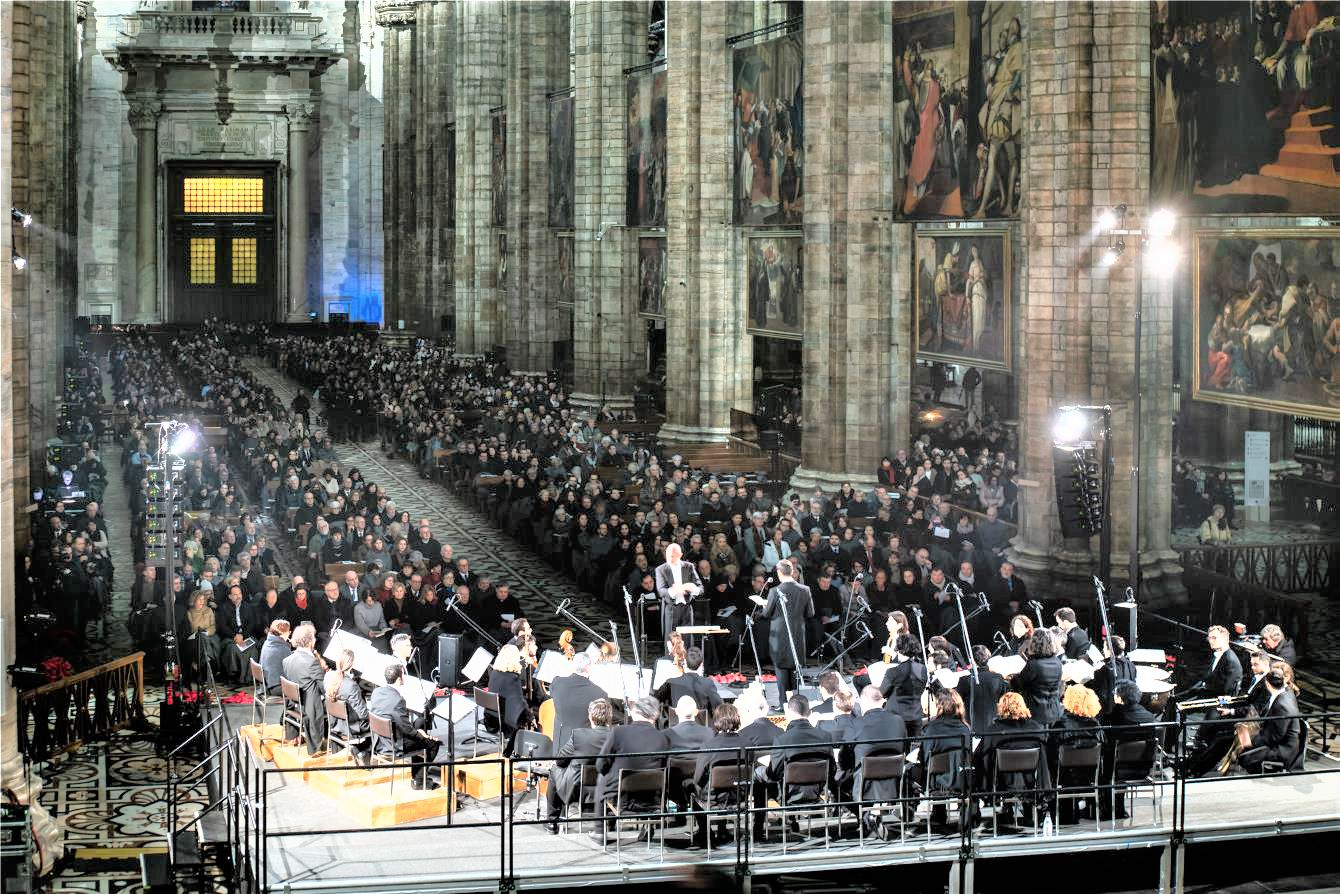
239;724;527;828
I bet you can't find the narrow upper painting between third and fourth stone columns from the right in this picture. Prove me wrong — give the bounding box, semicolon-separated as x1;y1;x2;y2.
624;67;666;227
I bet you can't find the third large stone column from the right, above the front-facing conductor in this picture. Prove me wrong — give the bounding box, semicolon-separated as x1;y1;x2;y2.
661;0;754;441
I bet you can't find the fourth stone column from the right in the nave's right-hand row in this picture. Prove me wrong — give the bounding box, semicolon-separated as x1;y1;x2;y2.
570;0;643;407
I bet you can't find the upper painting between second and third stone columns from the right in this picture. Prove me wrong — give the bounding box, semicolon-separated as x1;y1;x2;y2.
733;35;805;227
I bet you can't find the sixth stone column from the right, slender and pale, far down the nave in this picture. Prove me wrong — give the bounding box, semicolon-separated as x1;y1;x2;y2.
453;0;506;354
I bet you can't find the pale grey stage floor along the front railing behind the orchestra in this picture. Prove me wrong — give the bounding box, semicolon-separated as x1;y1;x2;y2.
253;761;1340;894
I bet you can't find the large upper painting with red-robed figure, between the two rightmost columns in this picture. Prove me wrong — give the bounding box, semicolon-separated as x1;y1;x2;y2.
892;0;1026;220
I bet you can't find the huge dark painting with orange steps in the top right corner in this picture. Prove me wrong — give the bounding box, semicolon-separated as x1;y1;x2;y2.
1150;0;1340;214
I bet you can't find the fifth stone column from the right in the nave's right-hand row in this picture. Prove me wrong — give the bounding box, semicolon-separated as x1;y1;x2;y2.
504;0;570;373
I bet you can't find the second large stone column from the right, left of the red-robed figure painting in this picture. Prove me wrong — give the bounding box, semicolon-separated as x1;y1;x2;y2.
792;3;913;492
